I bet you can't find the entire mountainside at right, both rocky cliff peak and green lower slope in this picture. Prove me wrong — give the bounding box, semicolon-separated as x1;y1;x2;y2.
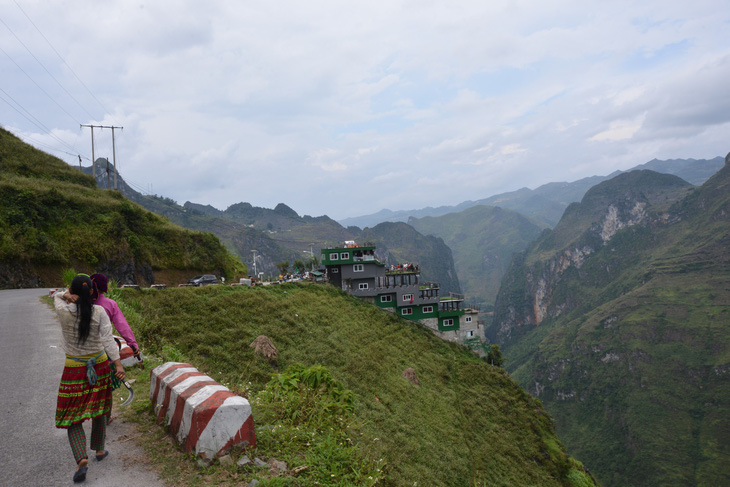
488;166;730;486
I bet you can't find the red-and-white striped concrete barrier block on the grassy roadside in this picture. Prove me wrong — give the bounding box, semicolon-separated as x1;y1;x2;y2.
150;362;256;458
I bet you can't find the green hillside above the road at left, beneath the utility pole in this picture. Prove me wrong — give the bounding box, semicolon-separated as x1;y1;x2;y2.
0;129;246;288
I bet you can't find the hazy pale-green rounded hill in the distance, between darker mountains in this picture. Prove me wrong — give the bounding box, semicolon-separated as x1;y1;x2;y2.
408;205;542;305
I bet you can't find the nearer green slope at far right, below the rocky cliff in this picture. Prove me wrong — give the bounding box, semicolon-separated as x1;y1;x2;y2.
498;167;730;486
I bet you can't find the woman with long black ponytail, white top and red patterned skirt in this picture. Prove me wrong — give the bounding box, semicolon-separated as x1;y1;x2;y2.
53;274;125;482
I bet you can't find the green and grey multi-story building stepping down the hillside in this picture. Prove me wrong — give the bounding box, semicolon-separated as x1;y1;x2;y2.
322;241;485;343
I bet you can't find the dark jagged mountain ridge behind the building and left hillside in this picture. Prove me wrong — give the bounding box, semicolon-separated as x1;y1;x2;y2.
83;159;461;293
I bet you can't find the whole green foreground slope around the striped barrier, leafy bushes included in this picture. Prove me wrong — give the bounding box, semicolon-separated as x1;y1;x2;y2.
115;284;592;486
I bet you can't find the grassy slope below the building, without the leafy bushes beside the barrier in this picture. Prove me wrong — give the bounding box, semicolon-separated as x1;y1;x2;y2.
121;285;590;486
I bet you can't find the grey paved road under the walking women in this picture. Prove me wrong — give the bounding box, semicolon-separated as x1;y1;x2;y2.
0;289;163;487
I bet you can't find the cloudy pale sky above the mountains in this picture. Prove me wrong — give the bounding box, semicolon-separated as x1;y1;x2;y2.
0;0;730;219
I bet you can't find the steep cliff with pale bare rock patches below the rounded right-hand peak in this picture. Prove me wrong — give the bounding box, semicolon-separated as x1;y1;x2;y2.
487;170;692;343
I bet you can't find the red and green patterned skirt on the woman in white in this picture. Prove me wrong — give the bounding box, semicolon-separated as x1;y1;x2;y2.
56;353;112;428
